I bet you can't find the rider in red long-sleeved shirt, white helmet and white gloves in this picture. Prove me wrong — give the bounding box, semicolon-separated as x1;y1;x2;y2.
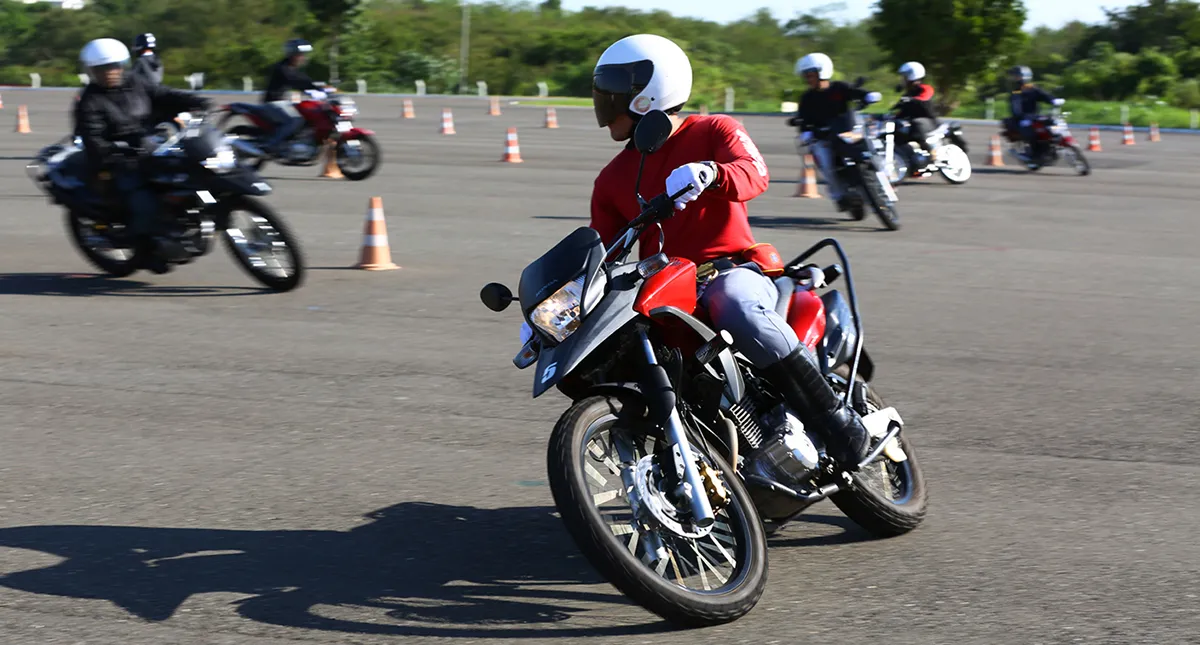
590;34;870;469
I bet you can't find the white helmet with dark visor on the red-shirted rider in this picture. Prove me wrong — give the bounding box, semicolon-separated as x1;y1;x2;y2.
592;34;691;127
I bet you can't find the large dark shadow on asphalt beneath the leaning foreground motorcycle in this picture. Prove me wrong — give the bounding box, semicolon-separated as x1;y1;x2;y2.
0;502;883;638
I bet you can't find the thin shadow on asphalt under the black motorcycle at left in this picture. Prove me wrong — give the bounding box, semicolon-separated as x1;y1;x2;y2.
0;273;267;297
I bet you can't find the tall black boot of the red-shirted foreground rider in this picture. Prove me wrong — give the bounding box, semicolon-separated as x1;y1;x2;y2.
763;345;871;471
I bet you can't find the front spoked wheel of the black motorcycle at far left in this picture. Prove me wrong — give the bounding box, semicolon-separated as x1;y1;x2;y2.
224;197;304;291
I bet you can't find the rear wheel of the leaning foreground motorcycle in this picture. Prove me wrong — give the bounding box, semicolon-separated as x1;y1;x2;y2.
830;367;929;537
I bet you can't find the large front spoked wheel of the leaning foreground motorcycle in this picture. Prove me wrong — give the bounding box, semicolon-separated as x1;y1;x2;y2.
547;396;767;627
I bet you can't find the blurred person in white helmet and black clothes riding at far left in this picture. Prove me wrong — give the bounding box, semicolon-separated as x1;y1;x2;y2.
74;38;211;273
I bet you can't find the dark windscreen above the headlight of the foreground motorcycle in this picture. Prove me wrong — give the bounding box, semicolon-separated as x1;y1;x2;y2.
517;227;604;320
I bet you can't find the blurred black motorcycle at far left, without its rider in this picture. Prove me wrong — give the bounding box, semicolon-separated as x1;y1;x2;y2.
26;114;304;291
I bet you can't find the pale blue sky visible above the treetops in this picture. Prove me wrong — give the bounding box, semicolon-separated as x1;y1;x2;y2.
563;0;1140;28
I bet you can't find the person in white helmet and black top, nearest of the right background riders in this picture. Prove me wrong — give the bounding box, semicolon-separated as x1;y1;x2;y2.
788;53;881;212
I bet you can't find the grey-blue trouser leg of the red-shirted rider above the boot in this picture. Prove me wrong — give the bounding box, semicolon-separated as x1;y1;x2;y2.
701;266;800;367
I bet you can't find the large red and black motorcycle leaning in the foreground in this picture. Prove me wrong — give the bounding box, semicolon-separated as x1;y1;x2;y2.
480;110;925;627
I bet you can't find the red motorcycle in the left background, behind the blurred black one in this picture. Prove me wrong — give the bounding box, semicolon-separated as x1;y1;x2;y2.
220;94;379;181
